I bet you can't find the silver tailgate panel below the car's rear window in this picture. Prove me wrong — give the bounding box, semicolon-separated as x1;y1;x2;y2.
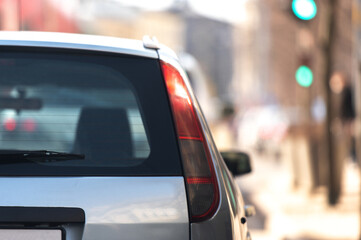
0;177;189;240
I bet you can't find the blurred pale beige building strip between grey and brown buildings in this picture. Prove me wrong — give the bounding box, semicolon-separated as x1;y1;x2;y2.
232;0;270;107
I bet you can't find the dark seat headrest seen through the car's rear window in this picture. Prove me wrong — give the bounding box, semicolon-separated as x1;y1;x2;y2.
73;108;133;163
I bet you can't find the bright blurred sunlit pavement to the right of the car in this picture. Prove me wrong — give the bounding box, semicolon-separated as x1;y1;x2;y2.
236;157;360;240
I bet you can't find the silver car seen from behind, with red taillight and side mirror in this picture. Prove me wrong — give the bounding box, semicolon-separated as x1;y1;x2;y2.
0;32;253;240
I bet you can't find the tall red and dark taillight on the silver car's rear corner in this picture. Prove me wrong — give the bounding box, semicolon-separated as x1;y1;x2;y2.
161;61;219;222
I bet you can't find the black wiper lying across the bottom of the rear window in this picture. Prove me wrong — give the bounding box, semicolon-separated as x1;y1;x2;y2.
0;150;85;164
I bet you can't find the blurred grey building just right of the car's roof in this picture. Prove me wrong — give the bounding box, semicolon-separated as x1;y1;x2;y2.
182;14;234;103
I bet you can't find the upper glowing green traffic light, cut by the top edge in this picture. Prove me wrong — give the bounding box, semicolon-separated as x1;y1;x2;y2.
292;0;317;21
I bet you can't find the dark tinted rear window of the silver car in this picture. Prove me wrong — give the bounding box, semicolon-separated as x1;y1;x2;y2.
0;47;181;176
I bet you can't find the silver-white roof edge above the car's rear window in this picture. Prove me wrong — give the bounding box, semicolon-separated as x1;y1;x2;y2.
0;31;158;58
